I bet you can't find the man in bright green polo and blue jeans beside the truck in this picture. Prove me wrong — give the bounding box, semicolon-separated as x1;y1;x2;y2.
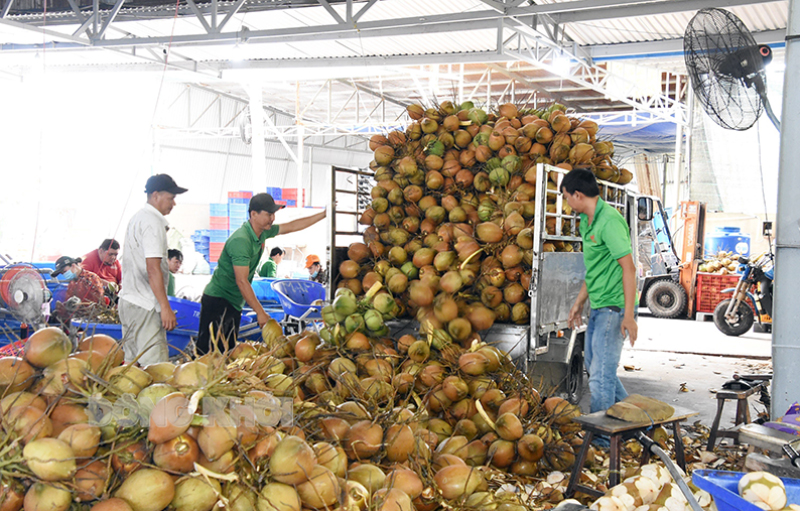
561;169;638;418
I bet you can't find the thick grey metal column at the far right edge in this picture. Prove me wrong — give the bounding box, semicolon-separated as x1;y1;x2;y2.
771;0;800;418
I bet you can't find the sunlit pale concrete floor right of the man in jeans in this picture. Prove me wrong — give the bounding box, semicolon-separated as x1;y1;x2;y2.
580;315;772;427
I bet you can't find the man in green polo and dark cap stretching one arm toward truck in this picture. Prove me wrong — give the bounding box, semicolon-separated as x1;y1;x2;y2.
197;193;327;354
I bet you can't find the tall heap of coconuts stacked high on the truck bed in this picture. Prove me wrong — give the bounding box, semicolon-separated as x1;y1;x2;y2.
337;101;632;346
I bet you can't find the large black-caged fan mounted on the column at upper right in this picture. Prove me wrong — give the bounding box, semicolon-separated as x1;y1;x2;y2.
683;8;781;131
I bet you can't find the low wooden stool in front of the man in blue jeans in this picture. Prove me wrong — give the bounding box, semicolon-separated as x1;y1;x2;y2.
565;407;698;498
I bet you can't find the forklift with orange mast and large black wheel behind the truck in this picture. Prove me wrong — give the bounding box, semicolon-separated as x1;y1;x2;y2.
638;199;706;318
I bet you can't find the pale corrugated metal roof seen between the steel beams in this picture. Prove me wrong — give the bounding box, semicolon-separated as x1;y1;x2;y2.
0;0;788;132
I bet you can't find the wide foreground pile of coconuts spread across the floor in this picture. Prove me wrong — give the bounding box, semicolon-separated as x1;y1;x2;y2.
0;304;592;511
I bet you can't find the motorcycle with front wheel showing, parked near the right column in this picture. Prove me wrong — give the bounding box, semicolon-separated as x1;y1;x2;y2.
714;252;775;336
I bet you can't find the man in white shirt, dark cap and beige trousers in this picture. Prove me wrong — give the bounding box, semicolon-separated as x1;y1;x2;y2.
119;174;186;366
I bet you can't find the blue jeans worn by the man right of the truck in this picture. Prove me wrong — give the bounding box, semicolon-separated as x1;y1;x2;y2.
583;307;628;412
